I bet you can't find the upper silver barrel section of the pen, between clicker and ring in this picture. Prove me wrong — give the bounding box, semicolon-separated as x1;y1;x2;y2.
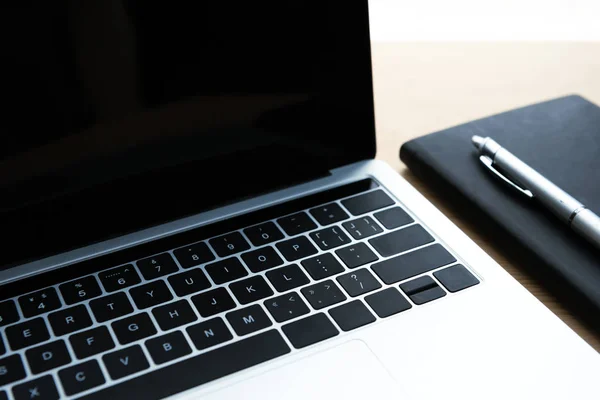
494;148;584;224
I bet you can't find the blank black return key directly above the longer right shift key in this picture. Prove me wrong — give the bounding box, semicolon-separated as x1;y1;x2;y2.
369;225;434;257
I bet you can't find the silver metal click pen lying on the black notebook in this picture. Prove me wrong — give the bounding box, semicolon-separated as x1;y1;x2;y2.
471;136;600;249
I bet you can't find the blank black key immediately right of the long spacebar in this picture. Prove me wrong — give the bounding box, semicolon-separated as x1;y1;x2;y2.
281;313;339;349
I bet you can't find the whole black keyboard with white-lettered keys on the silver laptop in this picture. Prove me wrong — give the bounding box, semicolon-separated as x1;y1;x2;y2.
0;180;479;400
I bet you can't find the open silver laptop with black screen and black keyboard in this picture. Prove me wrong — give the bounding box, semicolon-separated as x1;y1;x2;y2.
0;0;600;400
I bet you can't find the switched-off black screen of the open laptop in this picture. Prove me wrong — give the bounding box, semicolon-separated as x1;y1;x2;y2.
0;0;375;269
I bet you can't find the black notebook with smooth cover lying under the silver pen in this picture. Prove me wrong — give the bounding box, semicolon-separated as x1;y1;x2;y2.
400;96;600;330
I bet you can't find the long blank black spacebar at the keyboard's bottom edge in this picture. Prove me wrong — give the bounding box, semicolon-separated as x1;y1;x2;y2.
81;330;290;400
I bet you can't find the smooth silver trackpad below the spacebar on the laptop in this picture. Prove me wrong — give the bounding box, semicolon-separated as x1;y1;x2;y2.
202;340;407;400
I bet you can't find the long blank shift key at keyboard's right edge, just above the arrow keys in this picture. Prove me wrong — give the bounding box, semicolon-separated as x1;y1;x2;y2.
371;244;456;285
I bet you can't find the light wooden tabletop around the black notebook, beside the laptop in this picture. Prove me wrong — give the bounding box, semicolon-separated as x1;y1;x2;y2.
372;42;600;352
